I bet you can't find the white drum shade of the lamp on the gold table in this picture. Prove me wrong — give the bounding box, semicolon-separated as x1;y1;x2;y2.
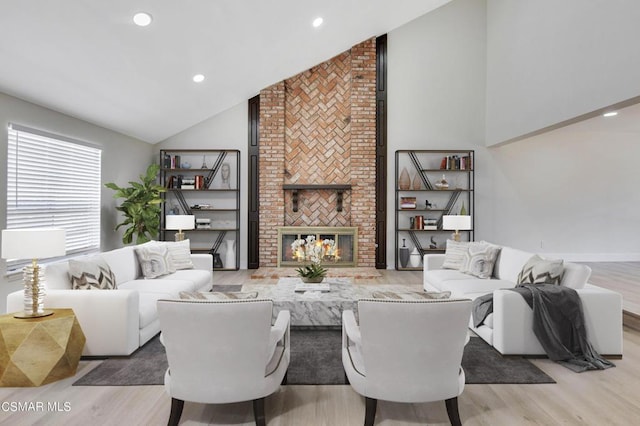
2;228;67;259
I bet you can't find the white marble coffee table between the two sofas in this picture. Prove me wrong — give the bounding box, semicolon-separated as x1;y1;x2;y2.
242;277;416;326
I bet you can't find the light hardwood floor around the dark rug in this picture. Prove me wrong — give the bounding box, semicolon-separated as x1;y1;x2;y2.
0;265;640;426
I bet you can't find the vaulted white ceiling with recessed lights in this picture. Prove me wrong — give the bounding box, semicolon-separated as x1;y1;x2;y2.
0;0;449;143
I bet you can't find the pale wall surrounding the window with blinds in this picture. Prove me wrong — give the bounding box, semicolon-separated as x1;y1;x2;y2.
0;93;152;312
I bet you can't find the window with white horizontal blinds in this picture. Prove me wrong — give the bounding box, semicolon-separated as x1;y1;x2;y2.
7;124;102;270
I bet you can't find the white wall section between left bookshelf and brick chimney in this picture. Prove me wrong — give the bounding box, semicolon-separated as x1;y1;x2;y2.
154;102;249;269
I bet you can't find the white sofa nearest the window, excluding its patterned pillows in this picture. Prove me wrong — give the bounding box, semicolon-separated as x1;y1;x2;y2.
7;246;213;356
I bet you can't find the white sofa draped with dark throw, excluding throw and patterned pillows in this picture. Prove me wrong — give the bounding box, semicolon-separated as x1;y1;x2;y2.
424;243;622;356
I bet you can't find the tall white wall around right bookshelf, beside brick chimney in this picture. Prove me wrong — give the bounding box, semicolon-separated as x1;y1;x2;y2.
387;0;493;268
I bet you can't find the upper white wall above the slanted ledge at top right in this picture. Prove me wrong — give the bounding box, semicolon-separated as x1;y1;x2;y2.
486;0;640;145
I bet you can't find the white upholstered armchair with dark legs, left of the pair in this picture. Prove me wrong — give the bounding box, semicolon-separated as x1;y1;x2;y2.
158;299;290;425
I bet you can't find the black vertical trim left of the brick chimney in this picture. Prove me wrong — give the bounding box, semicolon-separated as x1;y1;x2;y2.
247;95;260;269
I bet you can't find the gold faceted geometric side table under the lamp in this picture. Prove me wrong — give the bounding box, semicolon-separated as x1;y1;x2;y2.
0;309;86;387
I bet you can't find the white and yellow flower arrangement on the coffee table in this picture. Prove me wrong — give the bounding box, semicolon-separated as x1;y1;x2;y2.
291;235;338;282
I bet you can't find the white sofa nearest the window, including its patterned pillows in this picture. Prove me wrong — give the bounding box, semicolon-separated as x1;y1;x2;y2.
7;240;213;356
